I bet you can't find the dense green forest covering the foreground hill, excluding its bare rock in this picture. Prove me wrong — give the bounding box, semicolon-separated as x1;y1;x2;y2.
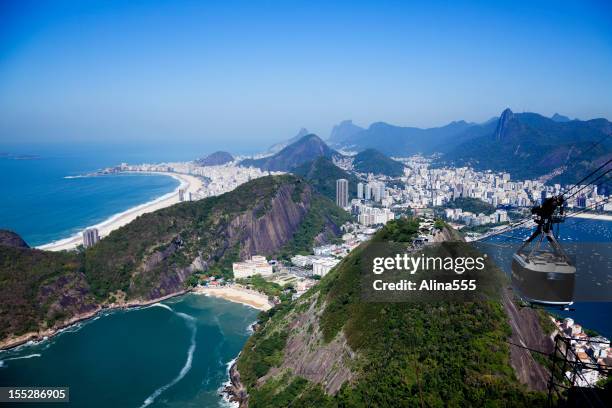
238;220;546;407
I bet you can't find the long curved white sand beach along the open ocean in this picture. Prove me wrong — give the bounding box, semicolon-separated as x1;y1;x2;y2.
37;172;203;251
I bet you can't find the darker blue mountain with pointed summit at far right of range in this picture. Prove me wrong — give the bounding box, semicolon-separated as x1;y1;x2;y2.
438;109;612;190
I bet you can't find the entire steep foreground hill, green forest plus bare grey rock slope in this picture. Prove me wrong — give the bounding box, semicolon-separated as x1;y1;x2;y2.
231;219;552;408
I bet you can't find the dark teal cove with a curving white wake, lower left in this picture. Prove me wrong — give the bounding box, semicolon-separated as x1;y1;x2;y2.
0;294;258;408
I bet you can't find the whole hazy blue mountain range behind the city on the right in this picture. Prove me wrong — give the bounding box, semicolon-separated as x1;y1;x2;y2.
322;109;612;191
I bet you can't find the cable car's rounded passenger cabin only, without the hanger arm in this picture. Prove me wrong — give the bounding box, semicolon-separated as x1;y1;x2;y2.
512;251;576;306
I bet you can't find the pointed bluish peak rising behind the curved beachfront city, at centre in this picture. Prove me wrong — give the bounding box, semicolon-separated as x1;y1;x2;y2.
240;134;338;171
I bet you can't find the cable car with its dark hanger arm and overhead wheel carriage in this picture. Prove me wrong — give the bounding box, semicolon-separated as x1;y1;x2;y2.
512;196;576;306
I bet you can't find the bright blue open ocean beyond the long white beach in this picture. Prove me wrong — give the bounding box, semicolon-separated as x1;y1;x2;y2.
0;147;179;246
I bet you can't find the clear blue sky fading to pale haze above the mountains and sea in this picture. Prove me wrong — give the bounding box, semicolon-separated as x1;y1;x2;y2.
0;0;612;150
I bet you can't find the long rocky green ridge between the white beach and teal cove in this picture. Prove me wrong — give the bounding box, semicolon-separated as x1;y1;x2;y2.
0;175;348;340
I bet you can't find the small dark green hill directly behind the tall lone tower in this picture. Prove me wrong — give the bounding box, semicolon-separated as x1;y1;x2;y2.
292;157;359;201
